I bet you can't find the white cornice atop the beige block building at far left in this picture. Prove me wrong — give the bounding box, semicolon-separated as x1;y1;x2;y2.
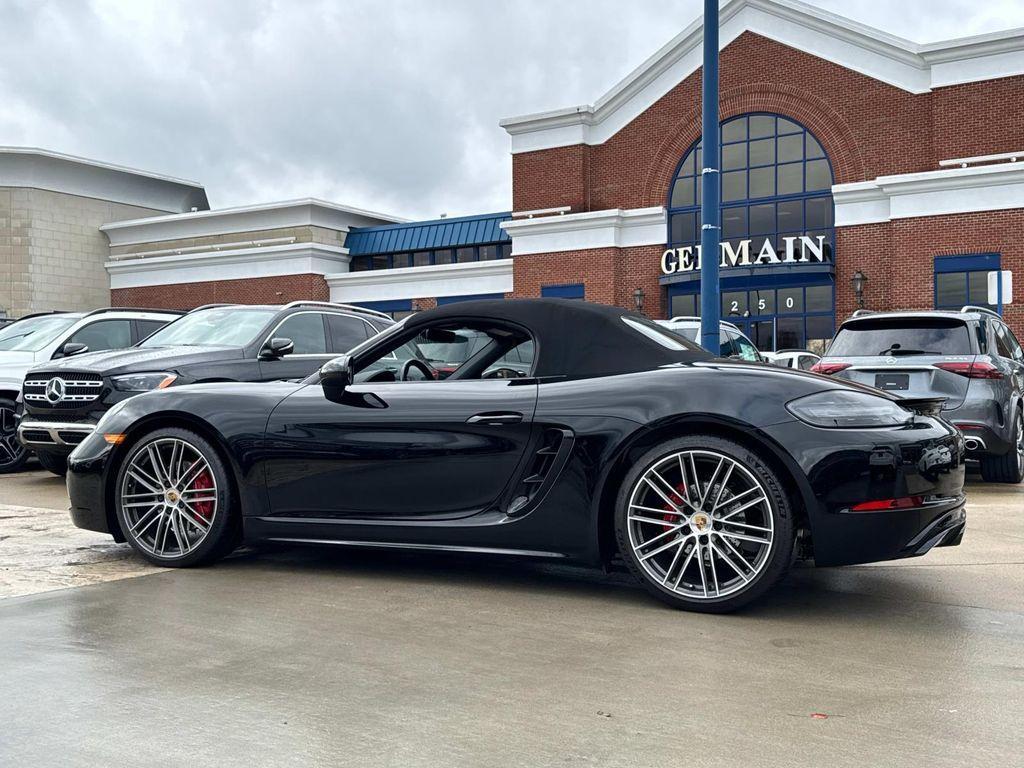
0;146;210;212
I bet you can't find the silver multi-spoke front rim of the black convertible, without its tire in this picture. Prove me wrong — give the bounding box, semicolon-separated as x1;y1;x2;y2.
121;437;217;558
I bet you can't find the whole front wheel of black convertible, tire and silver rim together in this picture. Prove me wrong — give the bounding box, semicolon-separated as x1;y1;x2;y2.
115;428;237;567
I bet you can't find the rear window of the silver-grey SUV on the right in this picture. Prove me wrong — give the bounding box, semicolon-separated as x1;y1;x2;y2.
828;318;974;357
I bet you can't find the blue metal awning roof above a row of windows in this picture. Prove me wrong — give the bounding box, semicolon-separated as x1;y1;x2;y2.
345;212;512;256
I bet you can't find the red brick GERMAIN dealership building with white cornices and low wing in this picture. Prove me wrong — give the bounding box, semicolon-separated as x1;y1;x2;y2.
8;0;1024;349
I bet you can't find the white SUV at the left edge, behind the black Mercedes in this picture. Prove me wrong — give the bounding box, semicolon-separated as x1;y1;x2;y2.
0;308;183;473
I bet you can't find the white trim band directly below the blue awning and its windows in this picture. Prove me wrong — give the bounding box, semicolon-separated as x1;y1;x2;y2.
326;259;512;304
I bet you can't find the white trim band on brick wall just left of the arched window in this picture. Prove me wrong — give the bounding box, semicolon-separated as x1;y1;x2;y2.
501;207;667;256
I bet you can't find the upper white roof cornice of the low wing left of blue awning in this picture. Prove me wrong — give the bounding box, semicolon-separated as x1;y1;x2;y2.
99;198;406;247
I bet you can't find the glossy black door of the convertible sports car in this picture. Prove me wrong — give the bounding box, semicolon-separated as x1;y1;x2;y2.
265;321;538;520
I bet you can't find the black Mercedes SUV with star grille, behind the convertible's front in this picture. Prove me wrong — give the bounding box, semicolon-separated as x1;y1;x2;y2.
17;301;401;474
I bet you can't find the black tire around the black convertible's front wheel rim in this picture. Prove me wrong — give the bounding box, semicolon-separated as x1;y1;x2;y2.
111;427;241;568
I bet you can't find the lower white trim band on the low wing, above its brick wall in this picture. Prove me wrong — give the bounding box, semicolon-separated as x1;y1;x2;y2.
104;243;351;289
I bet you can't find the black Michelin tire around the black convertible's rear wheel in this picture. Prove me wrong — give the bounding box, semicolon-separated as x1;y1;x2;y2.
615;434;795;613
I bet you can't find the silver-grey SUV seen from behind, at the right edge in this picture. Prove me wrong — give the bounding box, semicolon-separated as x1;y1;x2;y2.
811;306;1024;482
